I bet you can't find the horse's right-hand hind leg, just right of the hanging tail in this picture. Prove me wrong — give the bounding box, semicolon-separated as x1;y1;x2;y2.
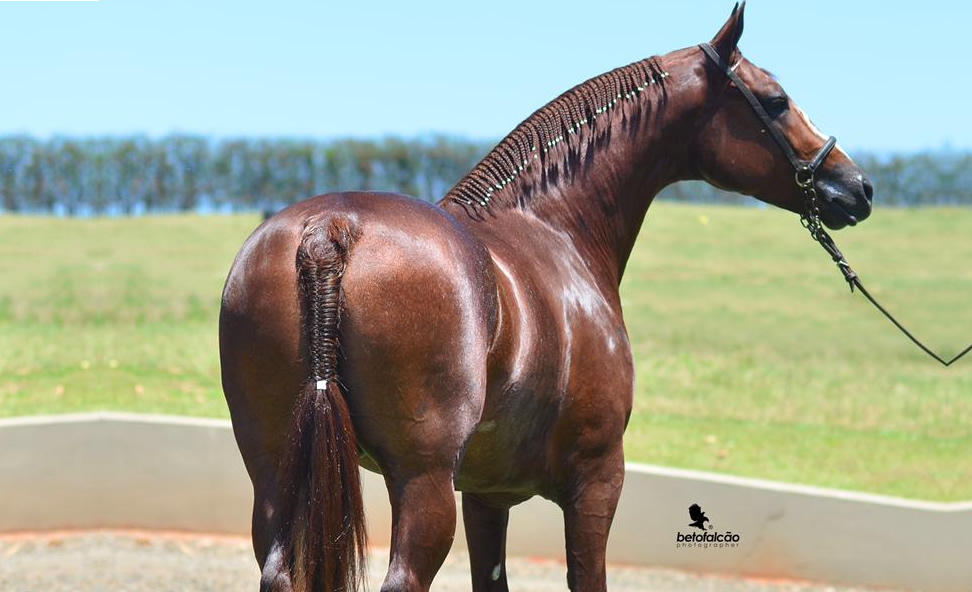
381;469;456;592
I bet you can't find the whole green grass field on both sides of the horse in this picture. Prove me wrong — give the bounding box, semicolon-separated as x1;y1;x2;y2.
0;204;972;500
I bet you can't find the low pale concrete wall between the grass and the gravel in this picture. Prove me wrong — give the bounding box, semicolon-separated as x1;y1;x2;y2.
0;413;960;592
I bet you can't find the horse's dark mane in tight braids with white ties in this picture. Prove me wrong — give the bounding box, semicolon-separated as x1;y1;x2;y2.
445;58;668;209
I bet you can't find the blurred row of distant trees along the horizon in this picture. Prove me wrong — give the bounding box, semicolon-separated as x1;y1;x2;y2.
0;136;972;216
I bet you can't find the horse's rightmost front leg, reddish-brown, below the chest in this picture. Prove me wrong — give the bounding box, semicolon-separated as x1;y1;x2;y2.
560;443;624;592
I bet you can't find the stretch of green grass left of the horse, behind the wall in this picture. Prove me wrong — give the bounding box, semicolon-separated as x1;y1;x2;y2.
0;216;249;417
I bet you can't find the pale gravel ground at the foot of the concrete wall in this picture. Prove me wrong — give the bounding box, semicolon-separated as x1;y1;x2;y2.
0;532;880;592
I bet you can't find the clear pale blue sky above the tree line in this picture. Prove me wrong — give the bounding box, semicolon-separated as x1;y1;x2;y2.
0;0;972;152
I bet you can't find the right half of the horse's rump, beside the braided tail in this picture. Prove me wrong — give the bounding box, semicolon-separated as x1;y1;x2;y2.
340;199;496;474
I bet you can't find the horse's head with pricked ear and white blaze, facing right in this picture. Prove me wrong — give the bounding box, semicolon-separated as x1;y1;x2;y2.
690;3;873;229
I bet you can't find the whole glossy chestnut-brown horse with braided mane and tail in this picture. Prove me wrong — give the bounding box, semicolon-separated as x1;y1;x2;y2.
220;6;872;592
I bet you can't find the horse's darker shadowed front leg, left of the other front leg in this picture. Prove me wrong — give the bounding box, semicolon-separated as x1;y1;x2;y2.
462;493;510;592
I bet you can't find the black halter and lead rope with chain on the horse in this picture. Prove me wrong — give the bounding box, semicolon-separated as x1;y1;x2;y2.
700;43;972;367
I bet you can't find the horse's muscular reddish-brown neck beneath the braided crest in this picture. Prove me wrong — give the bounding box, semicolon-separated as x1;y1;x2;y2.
443;52;698;288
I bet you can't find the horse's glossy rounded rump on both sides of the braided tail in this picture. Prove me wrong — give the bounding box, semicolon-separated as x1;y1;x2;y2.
220;193;496;470
